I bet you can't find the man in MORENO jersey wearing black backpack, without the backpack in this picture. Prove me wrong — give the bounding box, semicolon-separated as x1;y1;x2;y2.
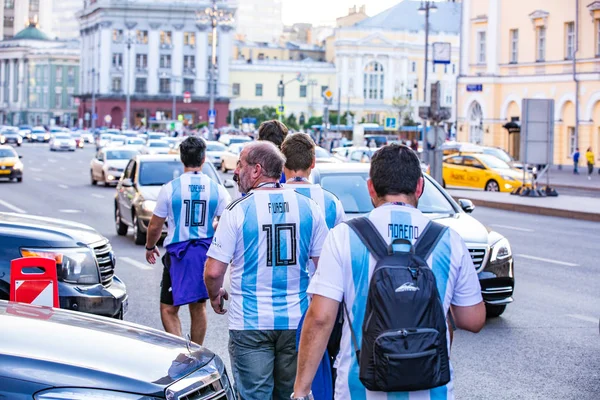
293;144;485;400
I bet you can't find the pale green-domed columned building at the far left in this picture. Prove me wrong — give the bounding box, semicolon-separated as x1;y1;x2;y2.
0;24;79;126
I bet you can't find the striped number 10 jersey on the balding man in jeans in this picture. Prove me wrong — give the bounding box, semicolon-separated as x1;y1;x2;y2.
207;189;327;330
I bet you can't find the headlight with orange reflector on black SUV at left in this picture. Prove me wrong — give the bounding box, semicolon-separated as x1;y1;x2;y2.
21;247;100;285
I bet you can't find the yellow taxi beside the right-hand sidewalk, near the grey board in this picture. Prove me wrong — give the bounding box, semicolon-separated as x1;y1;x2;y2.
443;154;531;192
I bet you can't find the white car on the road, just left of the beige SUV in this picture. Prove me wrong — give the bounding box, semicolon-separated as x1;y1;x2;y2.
90;146;139;186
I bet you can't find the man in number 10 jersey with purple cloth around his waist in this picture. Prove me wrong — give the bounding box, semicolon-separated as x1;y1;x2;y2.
146;136;231;344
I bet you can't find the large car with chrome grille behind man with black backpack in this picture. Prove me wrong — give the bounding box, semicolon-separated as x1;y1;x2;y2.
310;164;515;317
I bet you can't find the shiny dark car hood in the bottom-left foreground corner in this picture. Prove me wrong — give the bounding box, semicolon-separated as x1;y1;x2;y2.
0;301;234;400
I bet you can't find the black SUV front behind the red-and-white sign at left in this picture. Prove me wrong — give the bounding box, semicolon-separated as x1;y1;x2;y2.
0;213;127;318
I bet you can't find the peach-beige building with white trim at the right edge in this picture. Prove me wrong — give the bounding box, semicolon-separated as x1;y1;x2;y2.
457;0;600;165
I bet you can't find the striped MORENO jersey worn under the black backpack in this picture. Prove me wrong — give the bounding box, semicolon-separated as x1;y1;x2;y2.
308;204;482;400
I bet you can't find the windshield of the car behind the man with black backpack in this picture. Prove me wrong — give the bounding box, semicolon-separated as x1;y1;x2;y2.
321;173;455;214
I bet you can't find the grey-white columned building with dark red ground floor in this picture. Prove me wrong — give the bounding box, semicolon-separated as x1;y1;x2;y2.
78;0;235;127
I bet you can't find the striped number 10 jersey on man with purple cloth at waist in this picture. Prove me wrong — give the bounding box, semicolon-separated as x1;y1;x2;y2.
154;172;231;246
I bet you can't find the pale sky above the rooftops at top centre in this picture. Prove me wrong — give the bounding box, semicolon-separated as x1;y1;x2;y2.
281;0;404;26
